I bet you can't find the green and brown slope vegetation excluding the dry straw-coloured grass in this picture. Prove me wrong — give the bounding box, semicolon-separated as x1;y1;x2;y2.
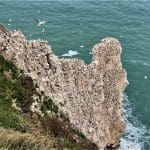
0;55;97;150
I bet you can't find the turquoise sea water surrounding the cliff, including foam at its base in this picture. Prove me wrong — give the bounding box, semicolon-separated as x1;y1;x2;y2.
0;0;150;150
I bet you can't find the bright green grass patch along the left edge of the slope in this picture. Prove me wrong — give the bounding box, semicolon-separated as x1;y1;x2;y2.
0;56;25;130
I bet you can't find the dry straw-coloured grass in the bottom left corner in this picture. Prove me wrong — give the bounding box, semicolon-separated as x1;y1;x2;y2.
0;127;57;150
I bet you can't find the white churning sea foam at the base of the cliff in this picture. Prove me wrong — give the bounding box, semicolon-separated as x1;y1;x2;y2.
120;95;150;150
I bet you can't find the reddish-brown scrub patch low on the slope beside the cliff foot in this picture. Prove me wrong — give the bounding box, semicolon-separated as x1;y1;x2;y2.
39;115;98;150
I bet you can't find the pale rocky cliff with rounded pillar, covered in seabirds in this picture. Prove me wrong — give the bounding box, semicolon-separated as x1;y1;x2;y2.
0;27;128;149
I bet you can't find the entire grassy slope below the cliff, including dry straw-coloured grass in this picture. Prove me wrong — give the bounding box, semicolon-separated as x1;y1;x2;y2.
0;55;97;150
